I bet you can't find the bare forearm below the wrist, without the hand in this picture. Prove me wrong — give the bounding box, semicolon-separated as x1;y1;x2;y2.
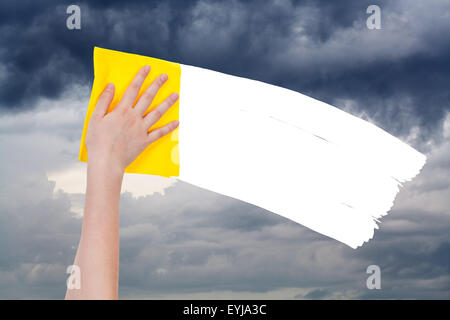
66;162;123;299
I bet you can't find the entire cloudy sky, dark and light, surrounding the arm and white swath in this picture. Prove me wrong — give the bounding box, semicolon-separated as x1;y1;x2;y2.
0;0;450;299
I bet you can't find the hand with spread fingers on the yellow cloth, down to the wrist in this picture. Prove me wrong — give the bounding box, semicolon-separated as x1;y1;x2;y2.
86;66;178;172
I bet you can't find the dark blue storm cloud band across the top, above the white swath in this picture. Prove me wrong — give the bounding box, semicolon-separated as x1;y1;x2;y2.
0;0;450;142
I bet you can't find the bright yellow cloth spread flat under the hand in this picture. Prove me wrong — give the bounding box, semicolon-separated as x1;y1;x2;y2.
79;47;181;177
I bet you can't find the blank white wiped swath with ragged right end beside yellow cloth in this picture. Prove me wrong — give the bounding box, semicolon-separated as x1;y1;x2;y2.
179;65;426;248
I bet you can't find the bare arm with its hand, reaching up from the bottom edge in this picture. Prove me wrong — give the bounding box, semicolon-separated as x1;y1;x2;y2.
66;66;178;299
